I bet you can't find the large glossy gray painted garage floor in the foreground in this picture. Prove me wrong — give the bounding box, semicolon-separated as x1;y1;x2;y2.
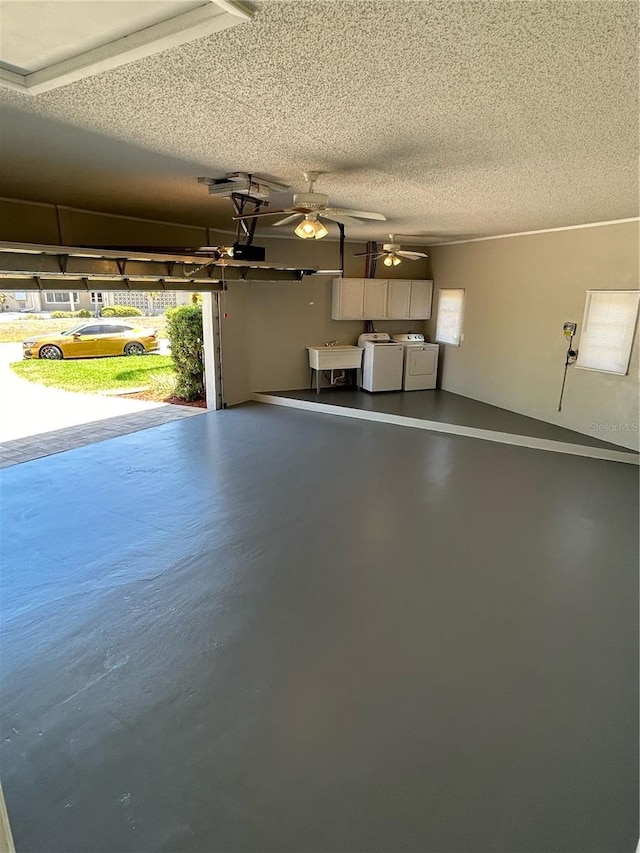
0;404;638;853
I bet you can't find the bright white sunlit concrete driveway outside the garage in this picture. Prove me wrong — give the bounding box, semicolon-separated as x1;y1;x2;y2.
0;343;165;442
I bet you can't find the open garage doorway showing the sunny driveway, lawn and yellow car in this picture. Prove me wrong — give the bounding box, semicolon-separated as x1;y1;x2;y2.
0;289;223;464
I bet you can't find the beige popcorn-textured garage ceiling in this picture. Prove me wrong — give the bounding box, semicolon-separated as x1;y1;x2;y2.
0;0;638;243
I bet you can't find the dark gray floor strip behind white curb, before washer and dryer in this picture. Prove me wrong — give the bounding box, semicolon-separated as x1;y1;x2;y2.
263;387;633;453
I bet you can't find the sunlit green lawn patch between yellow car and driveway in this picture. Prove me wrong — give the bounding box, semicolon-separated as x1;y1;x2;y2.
11;355;174;399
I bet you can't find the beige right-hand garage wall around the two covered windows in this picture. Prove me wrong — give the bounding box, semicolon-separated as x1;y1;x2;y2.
428;222;640;449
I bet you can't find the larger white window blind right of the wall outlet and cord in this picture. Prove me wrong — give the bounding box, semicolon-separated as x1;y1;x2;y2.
576;290;640;376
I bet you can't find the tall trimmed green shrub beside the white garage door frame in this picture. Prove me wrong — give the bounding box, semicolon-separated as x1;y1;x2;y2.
167;305;204;402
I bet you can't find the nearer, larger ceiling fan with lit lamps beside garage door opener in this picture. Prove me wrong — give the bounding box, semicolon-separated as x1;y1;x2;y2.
233;172;386;240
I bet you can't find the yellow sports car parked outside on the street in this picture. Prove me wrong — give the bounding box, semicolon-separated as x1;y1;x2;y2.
22;319;158;360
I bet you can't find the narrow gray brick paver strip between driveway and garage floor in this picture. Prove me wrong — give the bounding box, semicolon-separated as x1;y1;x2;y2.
0;404;204;468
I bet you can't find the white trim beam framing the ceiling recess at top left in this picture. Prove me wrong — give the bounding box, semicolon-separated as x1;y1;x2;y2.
0;0;253;95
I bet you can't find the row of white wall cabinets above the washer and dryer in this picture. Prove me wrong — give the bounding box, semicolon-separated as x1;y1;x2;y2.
331;278;433;320
